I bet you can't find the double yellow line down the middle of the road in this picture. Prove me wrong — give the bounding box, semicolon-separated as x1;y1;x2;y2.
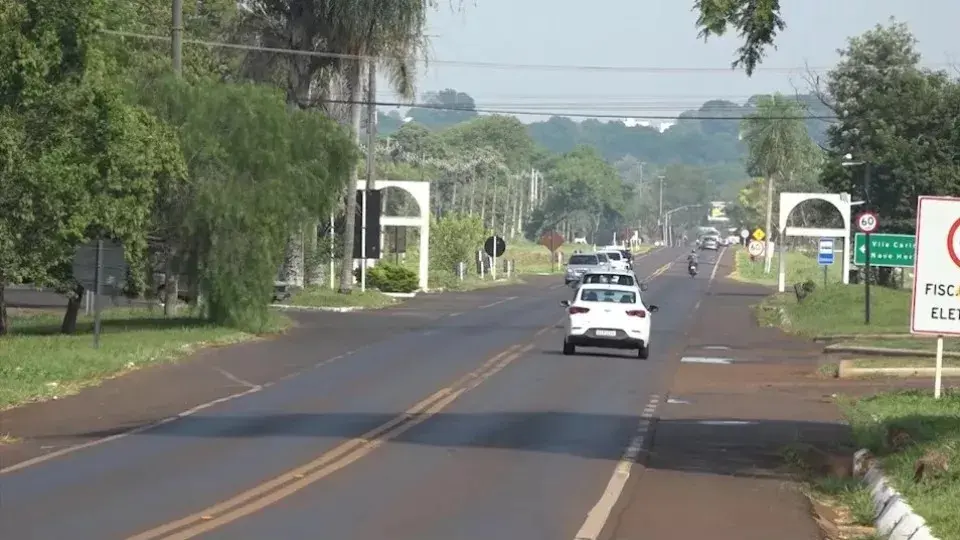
128;340;540;540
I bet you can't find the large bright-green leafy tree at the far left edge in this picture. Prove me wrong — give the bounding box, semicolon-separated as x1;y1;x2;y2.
0;0;183;332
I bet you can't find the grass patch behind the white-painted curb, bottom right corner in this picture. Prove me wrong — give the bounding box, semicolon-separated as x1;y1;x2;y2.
842;390;960;539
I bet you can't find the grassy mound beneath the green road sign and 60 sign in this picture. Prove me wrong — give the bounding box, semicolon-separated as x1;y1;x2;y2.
758;285;908;343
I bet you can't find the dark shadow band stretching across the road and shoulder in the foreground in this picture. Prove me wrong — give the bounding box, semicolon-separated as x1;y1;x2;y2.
43;411;852;480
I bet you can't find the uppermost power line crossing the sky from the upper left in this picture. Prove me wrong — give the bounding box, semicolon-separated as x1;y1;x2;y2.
101;29;950;74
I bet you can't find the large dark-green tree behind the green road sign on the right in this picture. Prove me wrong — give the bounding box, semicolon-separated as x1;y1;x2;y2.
821;19;960;282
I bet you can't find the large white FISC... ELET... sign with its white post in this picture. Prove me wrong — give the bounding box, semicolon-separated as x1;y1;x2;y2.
910;196;960;399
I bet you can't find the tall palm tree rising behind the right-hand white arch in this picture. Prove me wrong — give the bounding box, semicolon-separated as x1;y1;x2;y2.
740;93;816;272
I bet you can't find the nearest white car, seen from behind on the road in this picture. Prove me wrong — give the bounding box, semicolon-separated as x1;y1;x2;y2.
560;284;659;359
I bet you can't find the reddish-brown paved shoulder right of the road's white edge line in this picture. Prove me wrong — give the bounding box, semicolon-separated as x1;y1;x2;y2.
605;249;864;540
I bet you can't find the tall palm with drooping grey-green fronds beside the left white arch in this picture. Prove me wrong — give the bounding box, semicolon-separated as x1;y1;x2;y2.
236;0;436;292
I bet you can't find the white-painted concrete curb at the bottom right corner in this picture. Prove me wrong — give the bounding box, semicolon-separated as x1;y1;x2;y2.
853;448;938;540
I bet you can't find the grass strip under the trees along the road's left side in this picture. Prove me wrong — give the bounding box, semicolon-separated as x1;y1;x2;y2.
0;308;290;410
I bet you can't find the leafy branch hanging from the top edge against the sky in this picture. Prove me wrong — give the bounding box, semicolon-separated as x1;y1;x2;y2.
694;0;787;75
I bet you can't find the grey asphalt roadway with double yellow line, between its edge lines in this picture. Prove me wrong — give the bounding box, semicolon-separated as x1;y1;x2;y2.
0;249;714;540
